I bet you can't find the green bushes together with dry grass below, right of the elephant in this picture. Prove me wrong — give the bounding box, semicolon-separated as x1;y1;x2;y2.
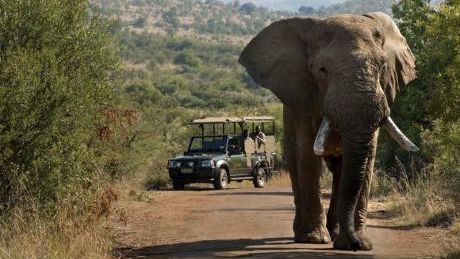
380;0;460;255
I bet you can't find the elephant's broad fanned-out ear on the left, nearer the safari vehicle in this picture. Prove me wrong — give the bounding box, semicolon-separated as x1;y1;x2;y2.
239;18;314;104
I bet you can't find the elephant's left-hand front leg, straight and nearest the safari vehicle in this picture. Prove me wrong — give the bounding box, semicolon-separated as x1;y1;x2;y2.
284;107;330;243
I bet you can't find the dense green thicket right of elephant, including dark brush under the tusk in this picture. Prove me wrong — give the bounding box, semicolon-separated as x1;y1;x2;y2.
380;0;460;208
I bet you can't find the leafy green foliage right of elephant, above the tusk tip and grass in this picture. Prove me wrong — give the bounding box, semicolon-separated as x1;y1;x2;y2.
386;0;460;176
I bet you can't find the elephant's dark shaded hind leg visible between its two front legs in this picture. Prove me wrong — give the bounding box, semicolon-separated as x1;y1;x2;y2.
324;156;342;240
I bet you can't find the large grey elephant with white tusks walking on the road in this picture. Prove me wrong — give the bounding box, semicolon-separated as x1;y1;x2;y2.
239;12;418;251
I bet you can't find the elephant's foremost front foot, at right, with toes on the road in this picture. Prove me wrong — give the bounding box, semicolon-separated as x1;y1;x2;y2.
334;231;372;251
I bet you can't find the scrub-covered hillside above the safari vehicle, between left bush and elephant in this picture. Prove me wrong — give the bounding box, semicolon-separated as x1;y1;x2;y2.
94;0;392;109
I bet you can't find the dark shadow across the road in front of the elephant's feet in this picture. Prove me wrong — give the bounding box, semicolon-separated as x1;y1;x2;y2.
114;237;374;259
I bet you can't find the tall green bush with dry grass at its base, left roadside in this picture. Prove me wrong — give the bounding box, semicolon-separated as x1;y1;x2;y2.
0;0;119;258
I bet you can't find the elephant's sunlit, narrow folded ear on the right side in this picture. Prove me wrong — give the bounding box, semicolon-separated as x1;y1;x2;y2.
364;12;416;100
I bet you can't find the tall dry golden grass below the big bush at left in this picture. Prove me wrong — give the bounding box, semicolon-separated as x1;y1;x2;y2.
0;189;115;259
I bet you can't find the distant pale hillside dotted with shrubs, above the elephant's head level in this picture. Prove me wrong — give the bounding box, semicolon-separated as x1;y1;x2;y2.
94;0;393;43
